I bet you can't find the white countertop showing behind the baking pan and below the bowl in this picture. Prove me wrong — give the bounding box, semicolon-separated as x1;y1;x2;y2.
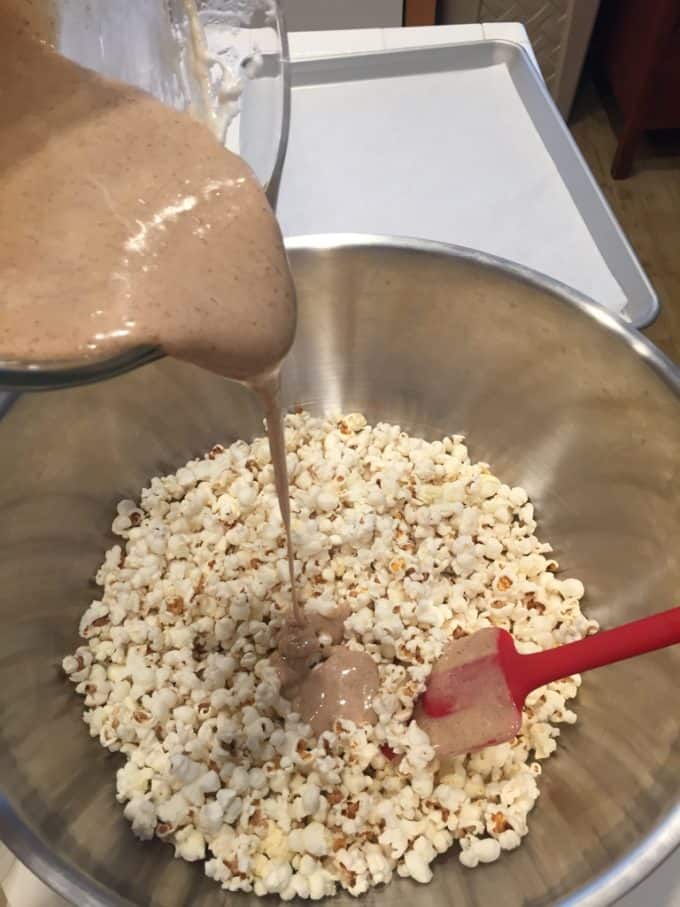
0;22;680;907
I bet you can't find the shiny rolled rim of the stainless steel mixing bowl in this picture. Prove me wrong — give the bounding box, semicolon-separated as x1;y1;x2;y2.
0;233;680;907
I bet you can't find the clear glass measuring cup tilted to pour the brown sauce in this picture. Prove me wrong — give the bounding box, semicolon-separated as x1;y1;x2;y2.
0;0;290;390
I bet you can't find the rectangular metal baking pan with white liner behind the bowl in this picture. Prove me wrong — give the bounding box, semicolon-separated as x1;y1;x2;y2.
264;41;659;327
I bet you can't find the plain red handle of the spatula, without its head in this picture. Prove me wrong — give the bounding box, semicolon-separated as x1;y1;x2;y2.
508;608;680;706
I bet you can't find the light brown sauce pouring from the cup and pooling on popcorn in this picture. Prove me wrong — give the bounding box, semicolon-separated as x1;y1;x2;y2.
0;0;378;733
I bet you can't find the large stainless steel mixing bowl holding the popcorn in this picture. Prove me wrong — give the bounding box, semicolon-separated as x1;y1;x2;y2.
0;237;680;907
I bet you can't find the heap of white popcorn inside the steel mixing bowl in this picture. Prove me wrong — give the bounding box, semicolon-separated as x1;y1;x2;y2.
62;413;597;901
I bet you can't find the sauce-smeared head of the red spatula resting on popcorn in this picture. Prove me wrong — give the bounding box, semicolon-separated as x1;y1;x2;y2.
414;627;522;756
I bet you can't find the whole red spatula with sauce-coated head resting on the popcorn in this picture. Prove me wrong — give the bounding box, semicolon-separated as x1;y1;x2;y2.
414;608;680;756
